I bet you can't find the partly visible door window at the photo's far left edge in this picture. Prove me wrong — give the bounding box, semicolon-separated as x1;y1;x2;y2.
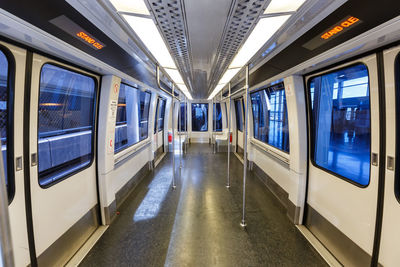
0;50;14;203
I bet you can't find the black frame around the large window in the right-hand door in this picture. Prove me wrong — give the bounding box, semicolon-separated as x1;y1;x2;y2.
305;61;372;188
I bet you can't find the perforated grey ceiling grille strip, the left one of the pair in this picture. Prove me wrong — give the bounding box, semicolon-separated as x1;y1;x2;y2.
147;0;193;92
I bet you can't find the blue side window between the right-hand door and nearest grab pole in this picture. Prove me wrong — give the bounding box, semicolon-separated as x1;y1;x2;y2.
250;83;289;152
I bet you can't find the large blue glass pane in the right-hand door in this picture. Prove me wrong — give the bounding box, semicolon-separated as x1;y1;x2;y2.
308;64;371;186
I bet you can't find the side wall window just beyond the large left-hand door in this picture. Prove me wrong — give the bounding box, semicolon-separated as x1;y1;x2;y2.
115;84;151;153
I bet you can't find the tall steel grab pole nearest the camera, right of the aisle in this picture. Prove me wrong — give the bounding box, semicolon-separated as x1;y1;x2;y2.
240;65;249;228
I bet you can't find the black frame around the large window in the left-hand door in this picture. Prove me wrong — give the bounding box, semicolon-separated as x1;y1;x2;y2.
36;60;100;189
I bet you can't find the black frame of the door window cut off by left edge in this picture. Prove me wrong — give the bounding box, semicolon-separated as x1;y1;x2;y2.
0;44;16;205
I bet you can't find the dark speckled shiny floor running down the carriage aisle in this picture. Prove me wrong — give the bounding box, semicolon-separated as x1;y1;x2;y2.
80;144;326;267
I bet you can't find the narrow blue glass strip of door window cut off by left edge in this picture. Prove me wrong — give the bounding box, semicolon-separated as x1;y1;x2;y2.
0;50;11;198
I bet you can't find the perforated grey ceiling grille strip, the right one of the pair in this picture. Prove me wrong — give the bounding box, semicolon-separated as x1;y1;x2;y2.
208;0;270;94
